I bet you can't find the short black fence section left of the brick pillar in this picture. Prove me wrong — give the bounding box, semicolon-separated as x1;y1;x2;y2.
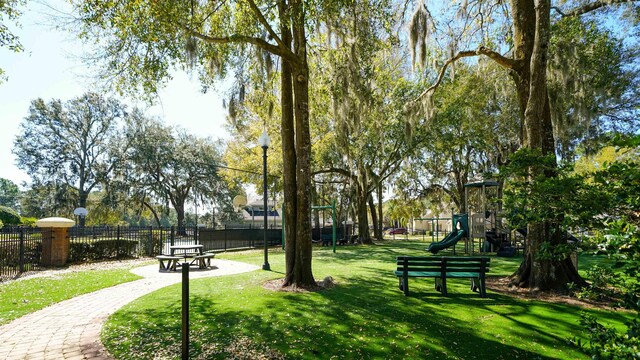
0;226;51;281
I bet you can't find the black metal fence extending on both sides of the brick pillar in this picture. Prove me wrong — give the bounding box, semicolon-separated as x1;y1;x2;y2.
0;226;282;281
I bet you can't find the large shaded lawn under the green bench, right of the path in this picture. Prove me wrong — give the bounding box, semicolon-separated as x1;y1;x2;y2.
102;241;632;359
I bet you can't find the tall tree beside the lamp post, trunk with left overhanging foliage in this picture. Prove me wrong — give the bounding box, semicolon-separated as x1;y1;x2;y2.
69;0;316;286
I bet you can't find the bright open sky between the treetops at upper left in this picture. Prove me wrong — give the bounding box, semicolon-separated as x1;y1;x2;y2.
0;0;228;185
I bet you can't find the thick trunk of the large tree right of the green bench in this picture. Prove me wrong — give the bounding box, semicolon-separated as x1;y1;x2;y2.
511;0;585;292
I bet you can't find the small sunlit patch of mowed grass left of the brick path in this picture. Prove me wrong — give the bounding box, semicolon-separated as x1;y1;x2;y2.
0;268;140;325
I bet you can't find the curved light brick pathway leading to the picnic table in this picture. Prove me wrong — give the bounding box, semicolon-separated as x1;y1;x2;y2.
0;259;259;360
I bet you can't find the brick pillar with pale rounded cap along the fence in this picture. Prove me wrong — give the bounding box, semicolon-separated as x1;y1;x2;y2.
36;218;74;266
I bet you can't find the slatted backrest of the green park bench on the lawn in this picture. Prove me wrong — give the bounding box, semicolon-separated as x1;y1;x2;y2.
396;256;491;273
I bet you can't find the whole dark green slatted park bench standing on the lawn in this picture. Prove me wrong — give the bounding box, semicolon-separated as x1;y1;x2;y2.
394;256;490;298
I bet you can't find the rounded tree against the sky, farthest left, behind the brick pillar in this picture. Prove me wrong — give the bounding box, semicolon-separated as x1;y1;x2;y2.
13;93;126;225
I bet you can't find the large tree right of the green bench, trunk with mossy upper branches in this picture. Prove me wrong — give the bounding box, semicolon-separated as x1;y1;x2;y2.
408;0;636;290
